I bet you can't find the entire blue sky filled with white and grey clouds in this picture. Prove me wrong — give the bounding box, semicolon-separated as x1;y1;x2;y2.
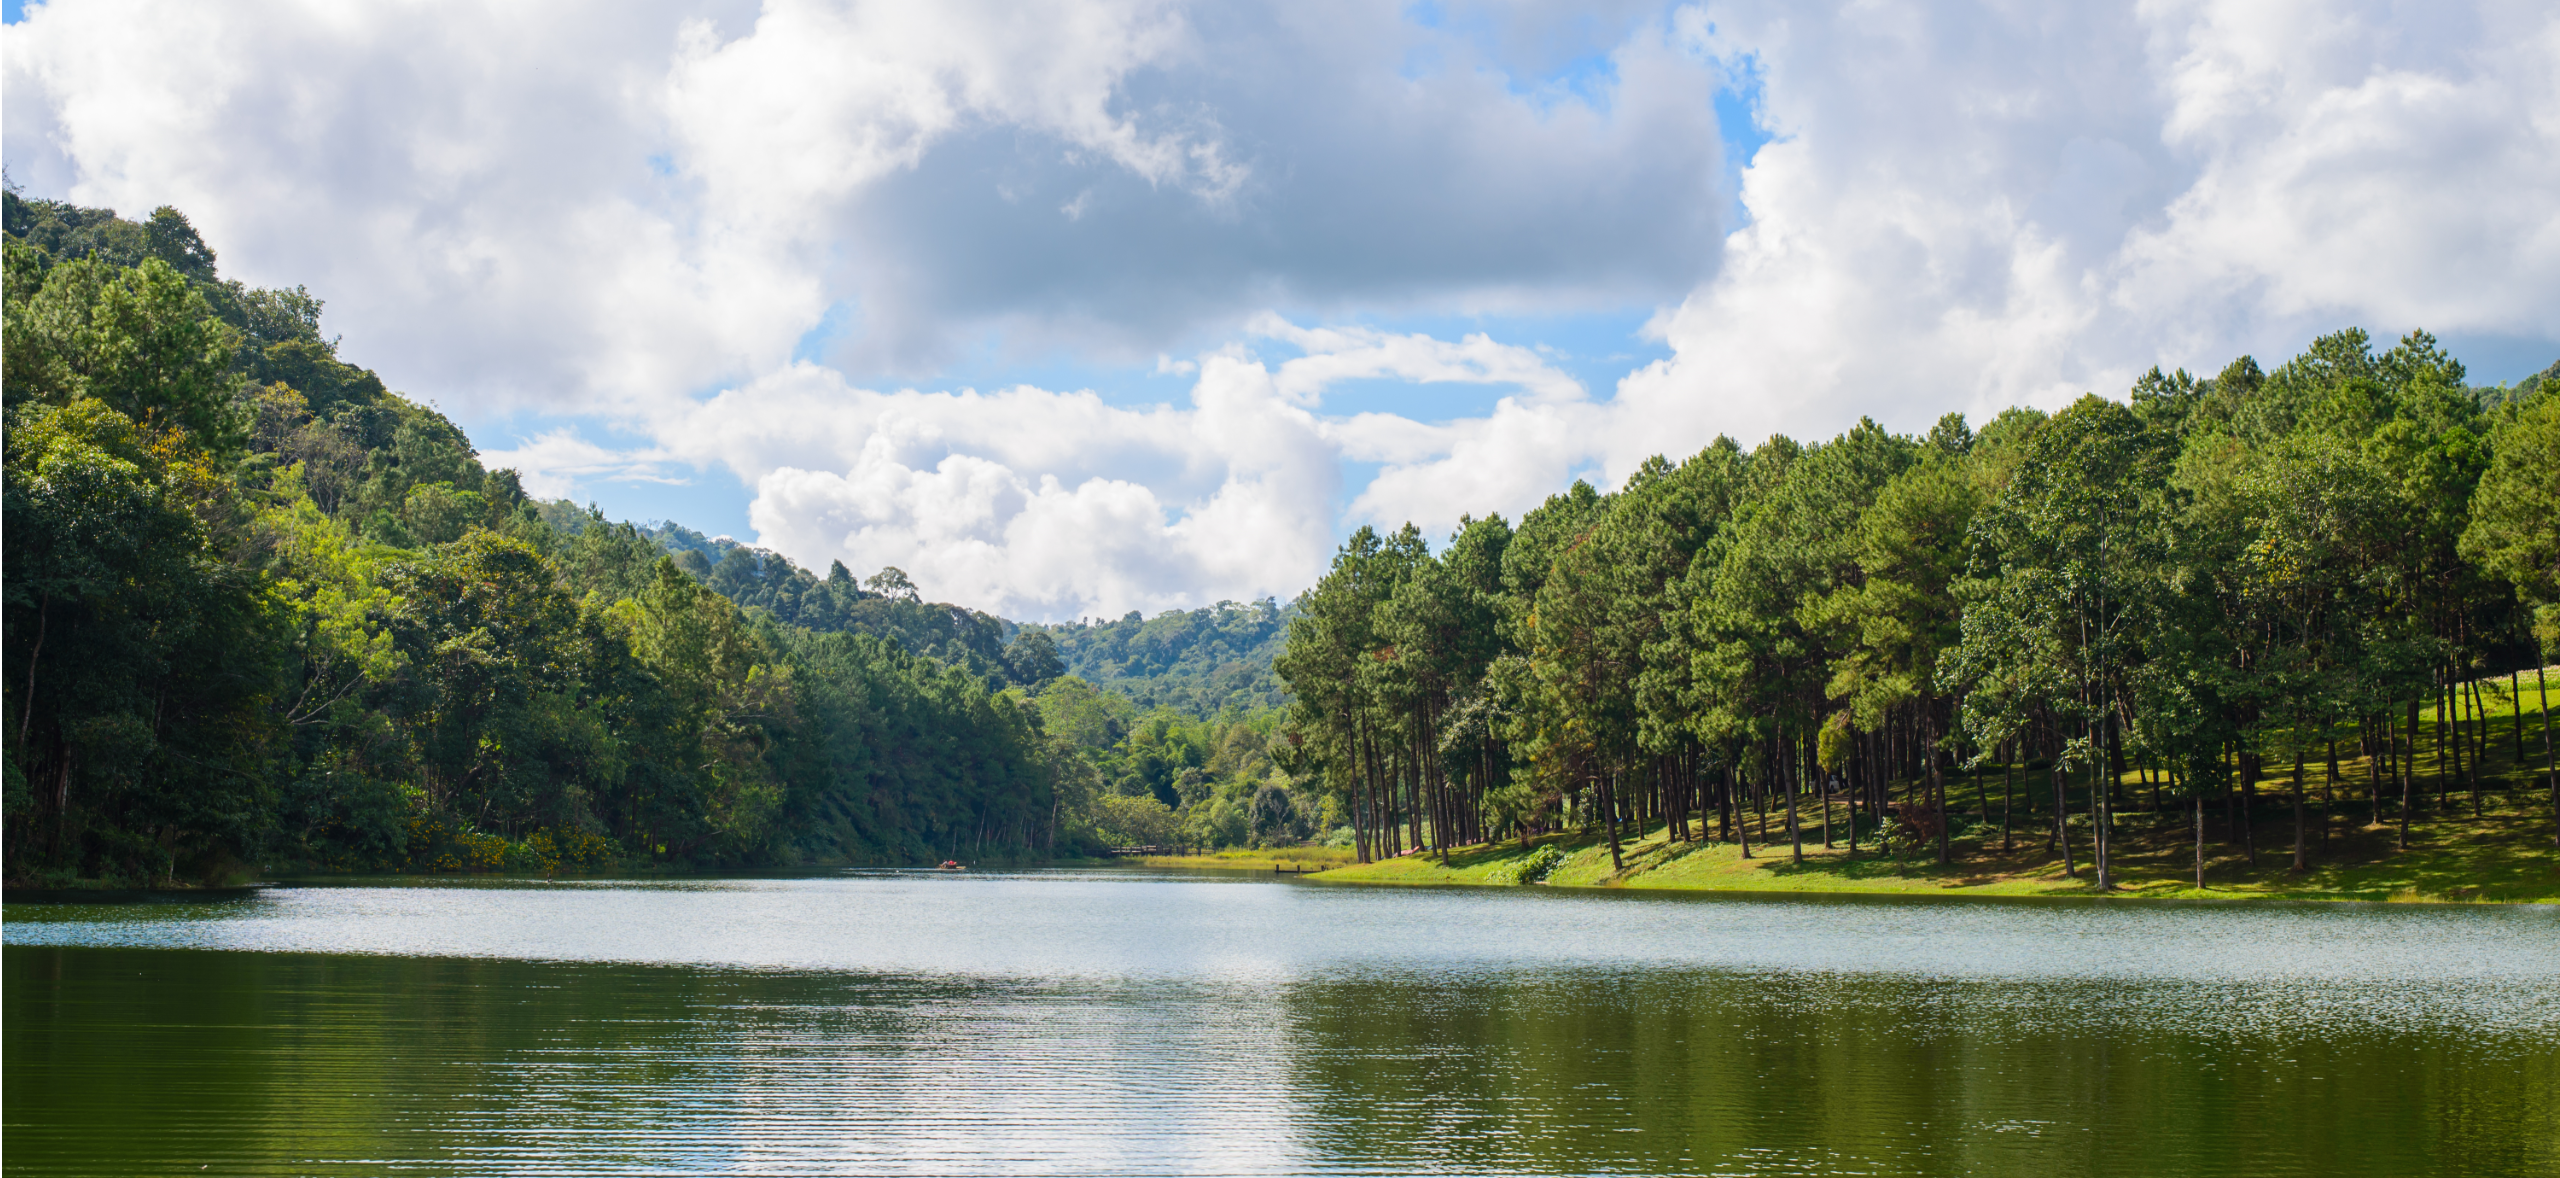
0;0;2560;620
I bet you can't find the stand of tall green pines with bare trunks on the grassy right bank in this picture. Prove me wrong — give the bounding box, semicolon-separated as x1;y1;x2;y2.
1277;330;2560;886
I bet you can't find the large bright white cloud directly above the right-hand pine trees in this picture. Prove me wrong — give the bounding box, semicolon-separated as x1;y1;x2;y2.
1605;0;2560;484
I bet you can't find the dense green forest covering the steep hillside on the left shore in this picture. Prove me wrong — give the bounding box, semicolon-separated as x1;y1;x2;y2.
0;192;1311;884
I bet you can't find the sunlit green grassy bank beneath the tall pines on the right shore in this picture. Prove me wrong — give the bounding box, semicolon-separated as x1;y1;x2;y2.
1310;668;2560;904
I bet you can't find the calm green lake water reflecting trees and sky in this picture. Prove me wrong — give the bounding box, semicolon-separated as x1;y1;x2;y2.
0;871;2560;1178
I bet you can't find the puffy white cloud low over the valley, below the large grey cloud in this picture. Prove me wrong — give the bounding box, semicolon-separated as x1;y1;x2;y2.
627;318;1585;617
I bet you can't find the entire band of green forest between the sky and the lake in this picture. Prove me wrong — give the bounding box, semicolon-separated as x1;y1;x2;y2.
0;190;2560;901
